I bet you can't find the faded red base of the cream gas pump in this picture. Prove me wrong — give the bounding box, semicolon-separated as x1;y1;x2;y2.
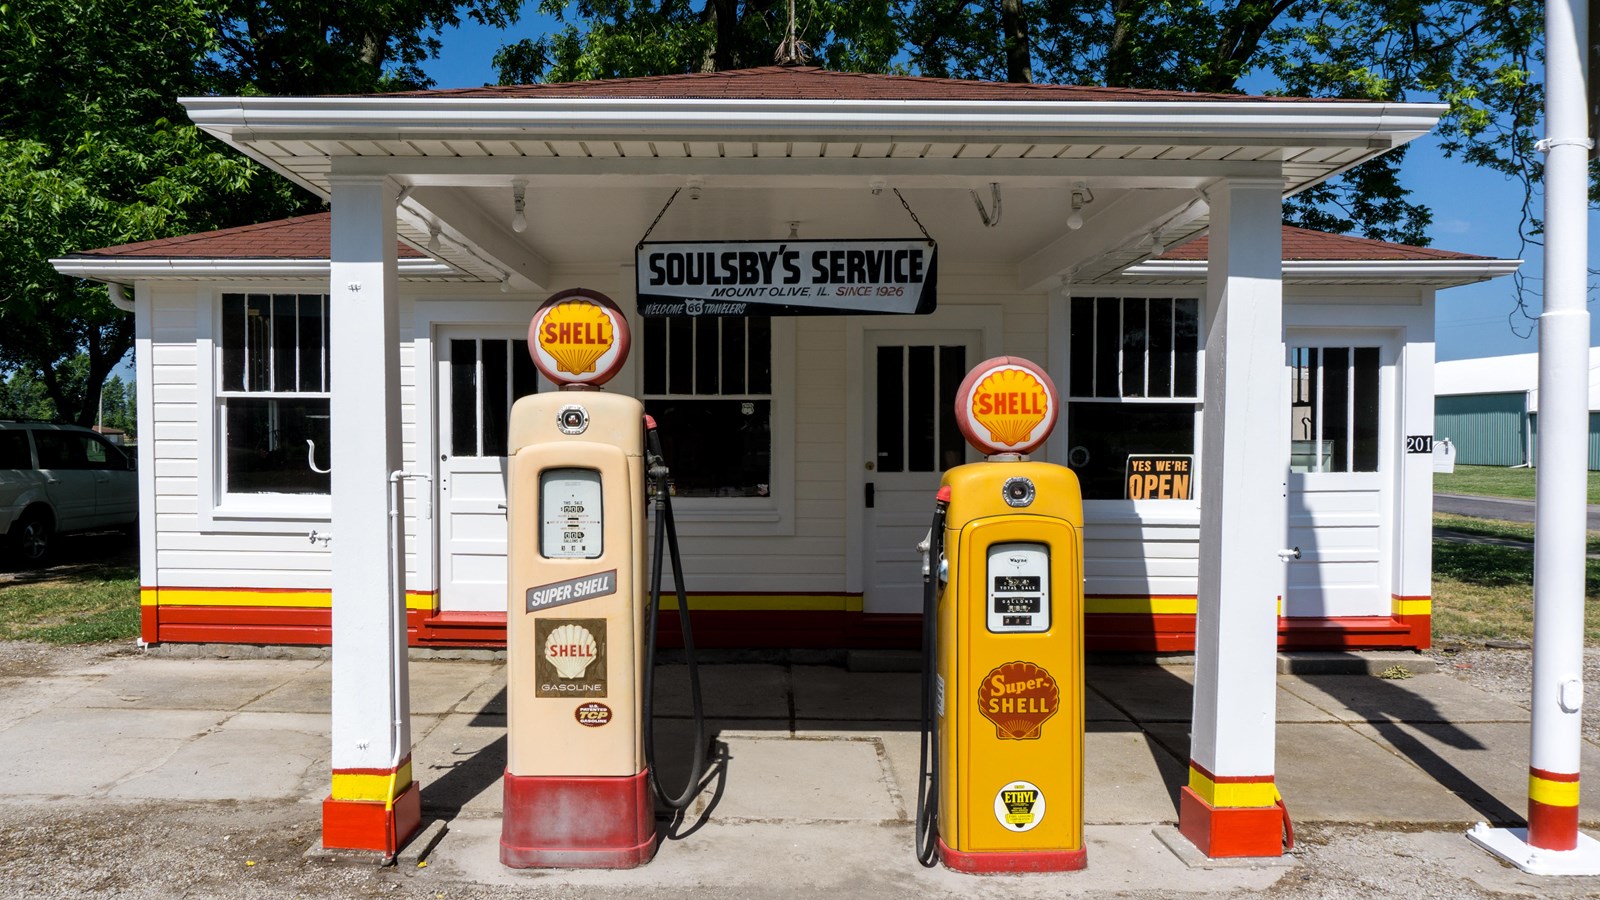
501;770;656;868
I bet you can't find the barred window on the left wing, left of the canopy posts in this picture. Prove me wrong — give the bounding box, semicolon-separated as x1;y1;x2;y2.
218;293;330;493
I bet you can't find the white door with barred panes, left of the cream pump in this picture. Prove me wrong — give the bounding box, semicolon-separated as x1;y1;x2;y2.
434;325;539;612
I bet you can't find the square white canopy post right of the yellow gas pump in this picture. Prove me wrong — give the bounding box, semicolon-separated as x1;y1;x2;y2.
1178;179;1290;857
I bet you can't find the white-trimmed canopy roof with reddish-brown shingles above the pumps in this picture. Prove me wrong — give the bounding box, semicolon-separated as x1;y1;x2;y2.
182;67;1445;290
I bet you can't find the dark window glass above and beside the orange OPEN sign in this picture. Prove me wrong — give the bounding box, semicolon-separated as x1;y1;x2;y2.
1067;296;1200;500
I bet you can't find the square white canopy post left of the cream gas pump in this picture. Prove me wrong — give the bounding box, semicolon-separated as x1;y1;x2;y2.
323;176;421;855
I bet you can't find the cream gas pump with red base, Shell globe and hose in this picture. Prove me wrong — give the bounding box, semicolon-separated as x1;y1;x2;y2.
501;288;706;868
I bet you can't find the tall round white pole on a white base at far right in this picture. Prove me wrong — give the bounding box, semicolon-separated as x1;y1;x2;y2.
1467;0;1600;874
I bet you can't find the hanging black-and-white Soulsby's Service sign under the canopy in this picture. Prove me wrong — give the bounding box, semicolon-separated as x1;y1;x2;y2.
635;239;938;315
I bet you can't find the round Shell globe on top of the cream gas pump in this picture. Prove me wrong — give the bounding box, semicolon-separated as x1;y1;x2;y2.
528;288;629;386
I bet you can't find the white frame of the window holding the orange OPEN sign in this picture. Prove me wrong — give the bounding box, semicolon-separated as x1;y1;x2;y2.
1051;285;1206;509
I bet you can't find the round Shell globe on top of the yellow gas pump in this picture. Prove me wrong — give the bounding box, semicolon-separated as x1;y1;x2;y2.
955;356;1061;456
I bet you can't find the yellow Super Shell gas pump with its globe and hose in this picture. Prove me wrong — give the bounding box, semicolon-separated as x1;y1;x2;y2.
917;357;1086;873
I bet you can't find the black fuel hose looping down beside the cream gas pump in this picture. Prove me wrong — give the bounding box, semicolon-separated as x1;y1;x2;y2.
642;416;706;810
